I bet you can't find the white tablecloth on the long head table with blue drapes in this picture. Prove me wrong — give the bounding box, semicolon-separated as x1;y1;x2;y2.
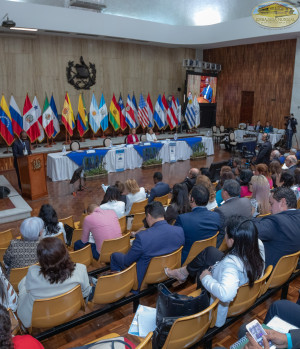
47;137;214;182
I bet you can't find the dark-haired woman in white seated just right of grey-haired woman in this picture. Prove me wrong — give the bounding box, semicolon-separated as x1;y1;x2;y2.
39;204;67;242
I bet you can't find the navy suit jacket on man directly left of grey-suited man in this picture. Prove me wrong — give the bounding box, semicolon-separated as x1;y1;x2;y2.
175;207;221;263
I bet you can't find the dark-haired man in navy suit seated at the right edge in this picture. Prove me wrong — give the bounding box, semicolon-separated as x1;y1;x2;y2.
254;187;300;267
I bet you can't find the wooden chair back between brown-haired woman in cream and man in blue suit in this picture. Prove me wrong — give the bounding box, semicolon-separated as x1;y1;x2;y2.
92;263;136;304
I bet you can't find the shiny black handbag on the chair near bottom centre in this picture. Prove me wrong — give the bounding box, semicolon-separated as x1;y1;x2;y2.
152;284;209;349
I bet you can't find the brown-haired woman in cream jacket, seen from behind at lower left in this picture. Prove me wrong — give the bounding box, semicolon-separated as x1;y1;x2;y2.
17;237;91;328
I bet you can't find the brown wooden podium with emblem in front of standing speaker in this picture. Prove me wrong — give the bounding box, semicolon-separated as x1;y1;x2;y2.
18;154;48;200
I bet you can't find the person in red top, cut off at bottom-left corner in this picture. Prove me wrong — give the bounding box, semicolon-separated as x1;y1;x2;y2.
0;305;44;349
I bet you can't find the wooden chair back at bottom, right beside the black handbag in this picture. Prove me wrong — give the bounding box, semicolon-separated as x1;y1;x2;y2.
163;299;219;349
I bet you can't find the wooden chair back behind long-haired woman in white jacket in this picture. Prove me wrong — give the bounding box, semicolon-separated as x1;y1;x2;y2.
227;265;273;317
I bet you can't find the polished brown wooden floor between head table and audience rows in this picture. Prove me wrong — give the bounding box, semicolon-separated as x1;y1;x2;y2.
0;146;300;349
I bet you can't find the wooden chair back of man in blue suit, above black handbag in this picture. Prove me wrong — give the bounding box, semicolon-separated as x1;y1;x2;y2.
138;246;183;290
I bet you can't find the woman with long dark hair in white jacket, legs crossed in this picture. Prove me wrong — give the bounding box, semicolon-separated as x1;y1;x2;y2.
165;216;265;327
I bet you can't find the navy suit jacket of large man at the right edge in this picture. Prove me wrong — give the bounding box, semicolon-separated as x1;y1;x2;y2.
254;210;300;267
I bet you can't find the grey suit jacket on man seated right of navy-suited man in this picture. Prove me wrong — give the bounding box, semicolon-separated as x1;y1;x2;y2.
214;197;252;247
